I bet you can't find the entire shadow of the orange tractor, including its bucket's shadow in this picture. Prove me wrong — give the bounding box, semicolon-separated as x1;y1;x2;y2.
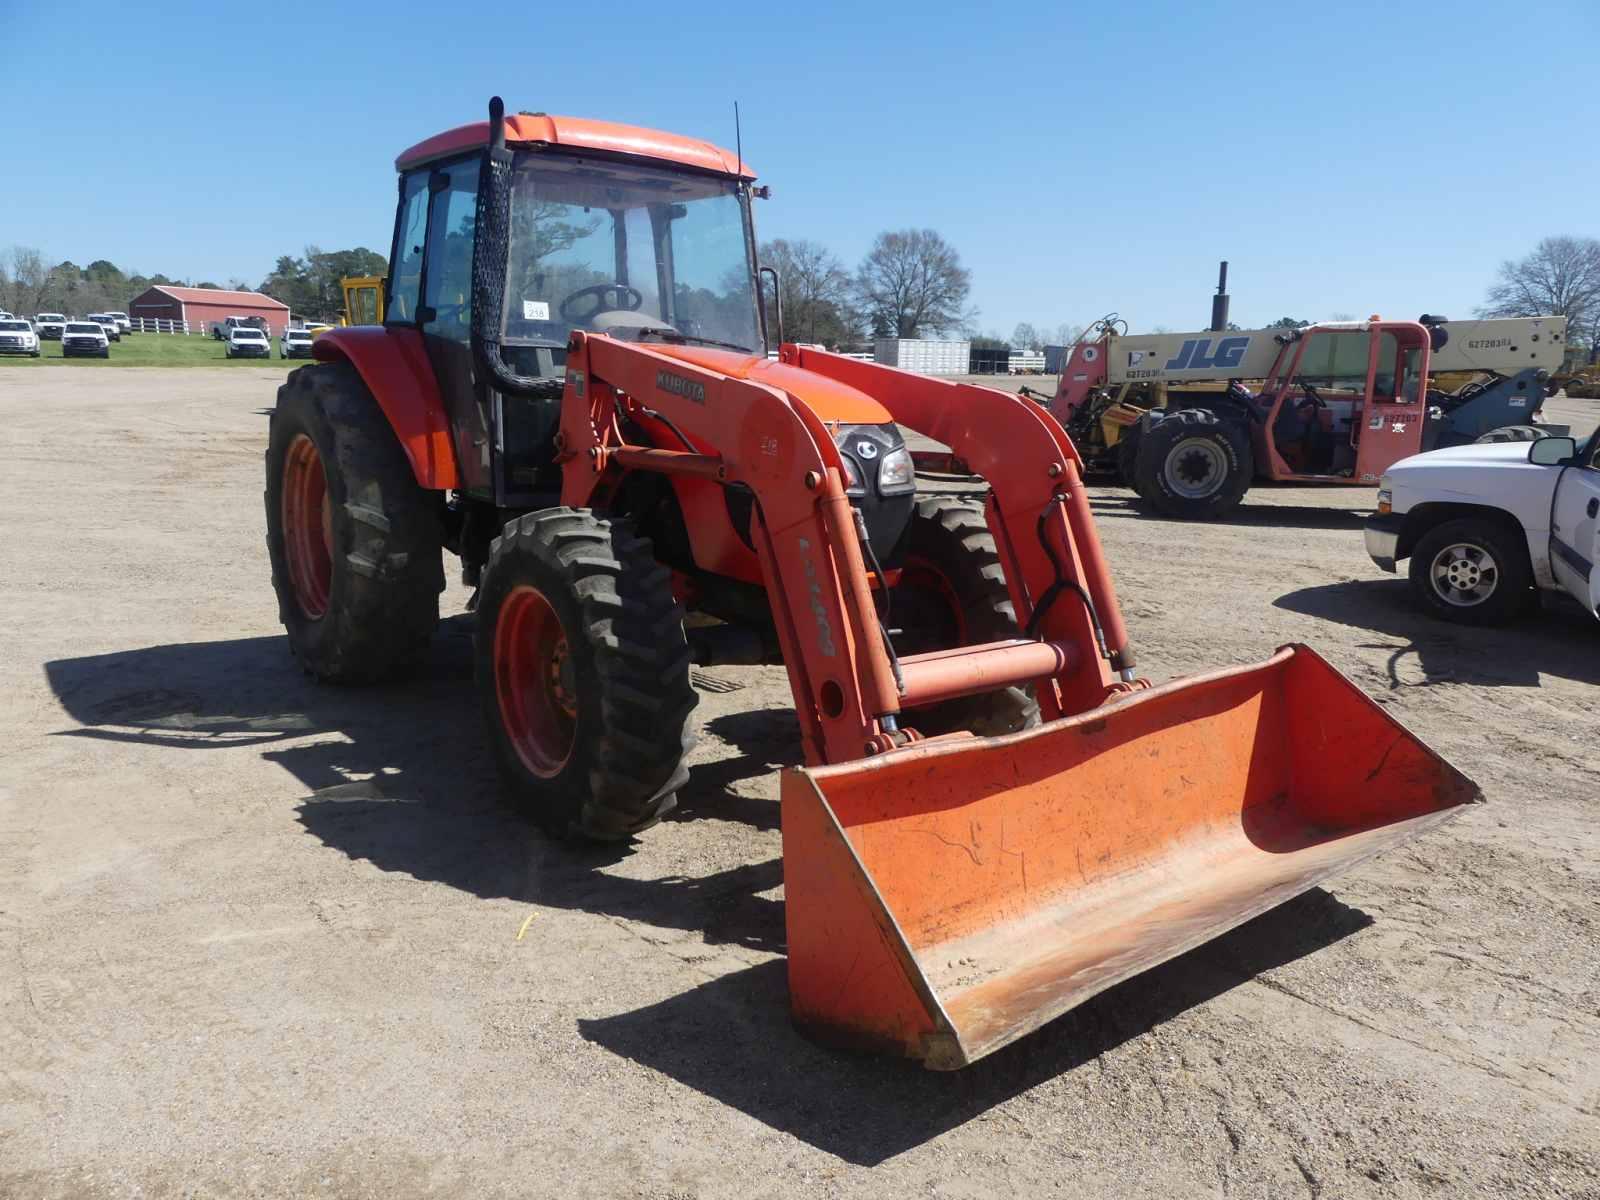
45;618;1371;1165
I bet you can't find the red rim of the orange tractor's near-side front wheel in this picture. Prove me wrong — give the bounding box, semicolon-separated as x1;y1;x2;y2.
494;584;578;779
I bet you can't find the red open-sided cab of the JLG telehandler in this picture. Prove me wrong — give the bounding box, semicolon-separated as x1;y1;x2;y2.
1253;318;1430;485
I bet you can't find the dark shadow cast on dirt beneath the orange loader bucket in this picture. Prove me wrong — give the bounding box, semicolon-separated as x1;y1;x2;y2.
578;888;1373;1166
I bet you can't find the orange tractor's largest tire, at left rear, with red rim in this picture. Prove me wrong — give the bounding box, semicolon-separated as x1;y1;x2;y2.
266;363;445;683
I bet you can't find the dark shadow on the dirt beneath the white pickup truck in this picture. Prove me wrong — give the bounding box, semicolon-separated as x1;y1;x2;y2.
1272;579;1600;688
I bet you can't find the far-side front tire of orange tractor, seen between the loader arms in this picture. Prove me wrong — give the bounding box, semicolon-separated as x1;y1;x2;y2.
890;496;1038;738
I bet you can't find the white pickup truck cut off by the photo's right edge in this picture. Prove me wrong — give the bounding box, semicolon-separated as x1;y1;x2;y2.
1366;430;1600;626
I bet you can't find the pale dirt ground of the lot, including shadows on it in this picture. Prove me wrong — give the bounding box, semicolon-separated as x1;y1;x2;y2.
0;370;1600;1200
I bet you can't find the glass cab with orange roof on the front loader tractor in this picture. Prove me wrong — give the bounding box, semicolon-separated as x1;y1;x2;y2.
384;114;766;507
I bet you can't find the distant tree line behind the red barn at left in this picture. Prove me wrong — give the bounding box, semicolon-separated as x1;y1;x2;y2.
0;246;389;320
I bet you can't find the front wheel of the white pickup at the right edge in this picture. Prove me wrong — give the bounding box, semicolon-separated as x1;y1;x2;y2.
1410;517;1533;626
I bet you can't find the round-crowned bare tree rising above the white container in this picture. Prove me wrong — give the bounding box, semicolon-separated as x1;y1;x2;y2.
856;229;973;338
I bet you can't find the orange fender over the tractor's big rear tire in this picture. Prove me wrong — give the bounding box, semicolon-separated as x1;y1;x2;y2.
310;325;461;491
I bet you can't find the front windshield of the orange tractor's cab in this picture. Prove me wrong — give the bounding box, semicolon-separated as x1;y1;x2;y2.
504;150;762;350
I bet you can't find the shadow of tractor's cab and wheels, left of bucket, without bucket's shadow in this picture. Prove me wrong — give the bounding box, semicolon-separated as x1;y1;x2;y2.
45;616;798;952
